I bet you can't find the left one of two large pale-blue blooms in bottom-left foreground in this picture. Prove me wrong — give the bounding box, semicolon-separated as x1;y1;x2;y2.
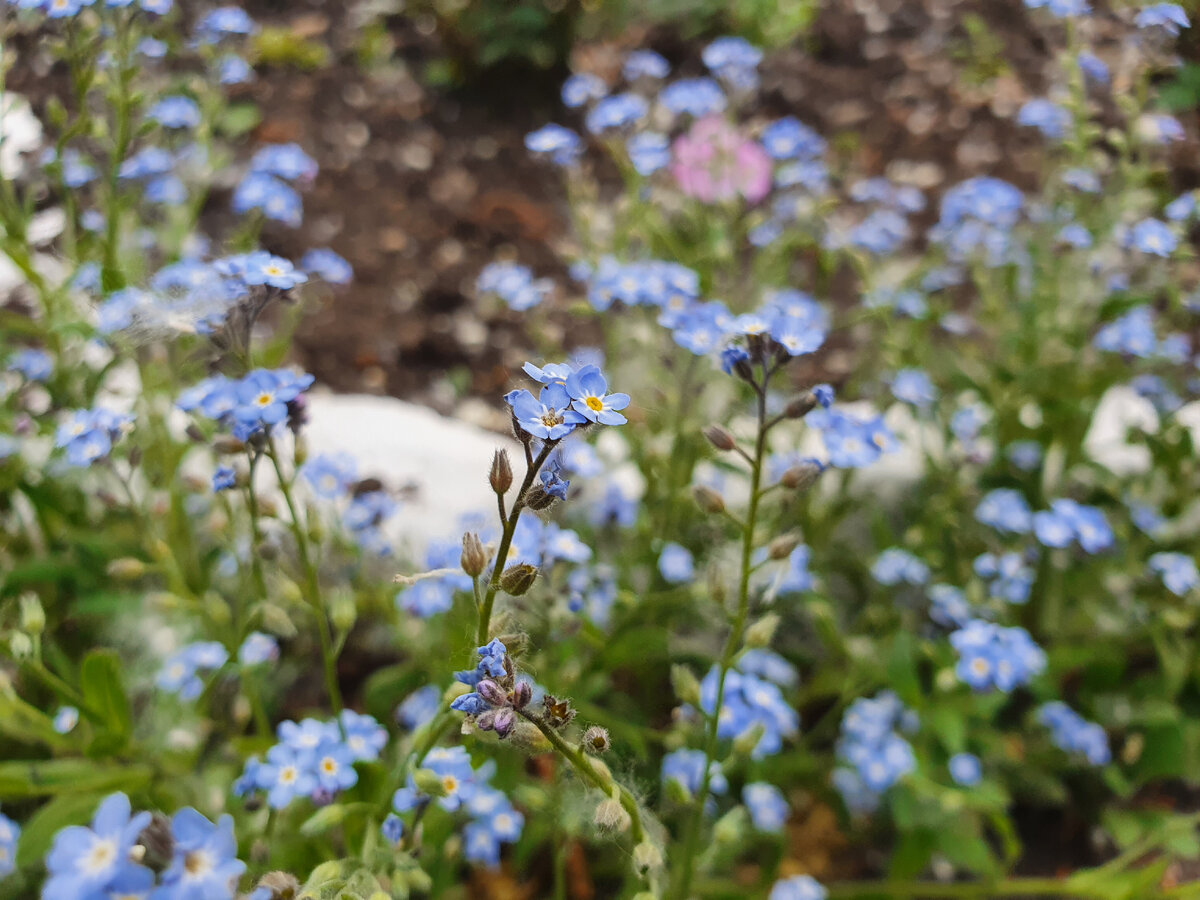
42;793;154;900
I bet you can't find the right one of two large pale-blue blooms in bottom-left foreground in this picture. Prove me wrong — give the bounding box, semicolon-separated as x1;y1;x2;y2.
150;806;246;900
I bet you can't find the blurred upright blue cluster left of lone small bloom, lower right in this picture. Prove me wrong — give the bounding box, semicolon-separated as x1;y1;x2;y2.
833;691;917;812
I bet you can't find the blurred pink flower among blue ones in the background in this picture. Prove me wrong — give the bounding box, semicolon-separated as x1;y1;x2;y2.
671;115;770;203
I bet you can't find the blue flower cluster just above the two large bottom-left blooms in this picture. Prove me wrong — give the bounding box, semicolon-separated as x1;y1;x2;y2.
234;709;388;809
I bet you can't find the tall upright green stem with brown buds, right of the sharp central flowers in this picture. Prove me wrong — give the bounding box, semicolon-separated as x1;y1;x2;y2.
672;367;769;900
